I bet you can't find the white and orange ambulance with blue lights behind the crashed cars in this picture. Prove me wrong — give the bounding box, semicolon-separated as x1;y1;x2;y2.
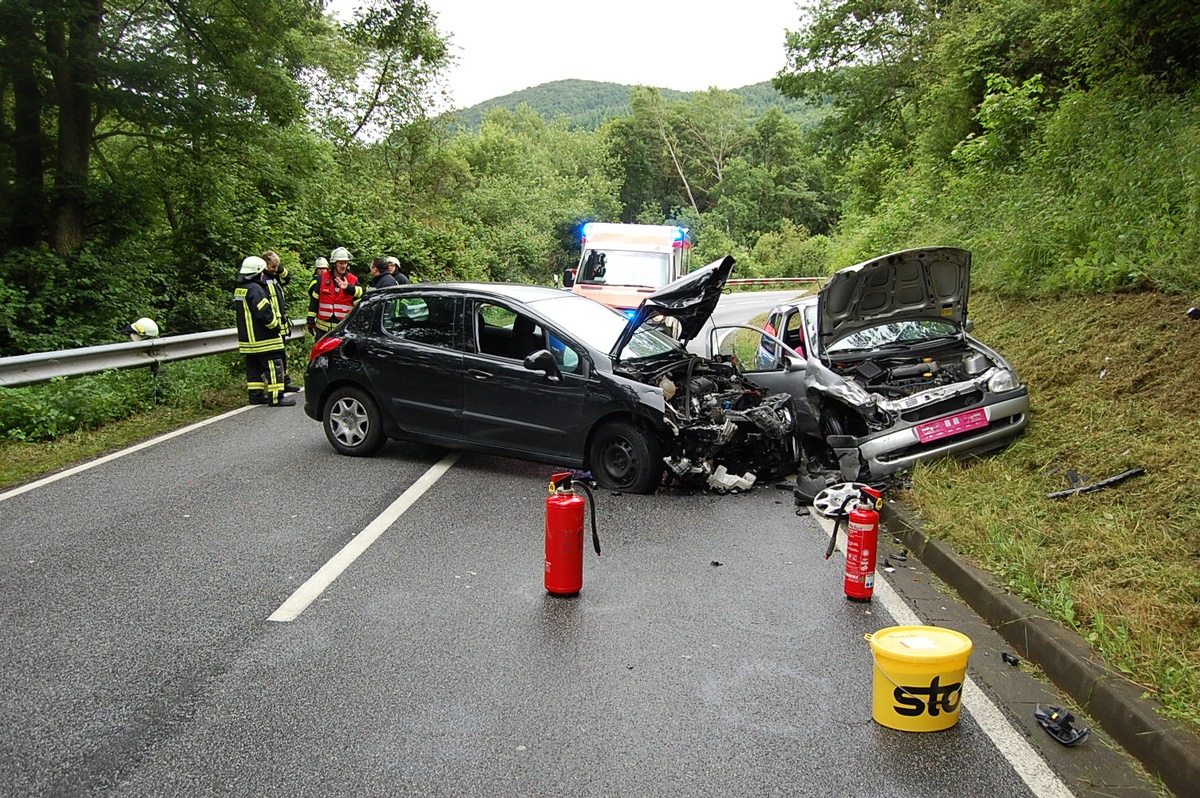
563;222;691;314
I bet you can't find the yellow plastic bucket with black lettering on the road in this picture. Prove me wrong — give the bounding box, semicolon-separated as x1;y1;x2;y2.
865;626;973;732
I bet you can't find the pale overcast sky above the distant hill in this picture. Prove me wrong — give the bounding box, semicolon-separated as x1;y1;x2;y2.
426;0;799;108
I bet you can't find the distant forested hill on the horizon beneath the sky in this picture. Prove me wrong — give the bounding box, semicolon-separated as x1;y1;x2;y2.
456;79;818;131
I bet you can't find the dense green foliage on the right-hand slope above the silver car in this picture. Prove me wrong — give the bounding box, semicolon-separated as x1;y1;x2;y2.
775;0;1200;294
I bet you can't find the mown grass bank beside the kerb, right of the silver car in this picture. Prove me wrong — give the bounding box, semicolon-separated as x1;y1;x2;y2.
901;293;1200;733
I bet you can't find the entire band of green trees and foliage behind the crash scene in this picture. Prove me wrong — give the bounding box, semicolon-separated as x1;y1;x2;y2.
0;0;1200;354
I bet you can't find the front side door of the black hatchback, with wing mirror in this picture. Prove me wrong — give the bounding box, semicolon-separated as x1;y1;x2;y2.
463;299;589;463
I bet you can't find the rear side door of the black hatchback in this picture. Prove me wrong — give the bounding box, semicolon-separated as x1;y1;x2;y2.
362;294;463;440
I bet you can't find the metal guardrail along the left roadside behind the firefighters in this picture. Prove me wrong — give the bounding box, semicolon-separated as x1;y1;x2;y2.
0;320;305;388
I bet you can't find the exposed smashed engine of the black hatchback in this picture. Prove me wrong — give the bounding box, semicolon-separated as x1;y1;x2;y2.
619;358;799;482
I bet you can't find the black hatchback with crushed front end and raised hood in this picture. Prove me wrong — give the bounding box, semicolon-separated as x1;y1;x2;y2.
305;257;799;492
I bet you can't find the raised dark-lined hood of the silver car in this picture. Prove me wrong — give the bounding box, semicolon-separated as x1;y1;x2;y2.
817;247;971;349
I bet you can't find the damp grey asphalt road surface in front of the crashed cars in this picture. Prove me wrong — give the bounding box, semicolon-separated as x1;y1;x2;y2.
0;289;1161;798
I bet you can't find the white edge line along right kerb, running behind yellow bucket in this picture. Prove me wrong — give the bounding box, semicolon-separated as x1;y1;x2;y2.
810;512;1074;798
